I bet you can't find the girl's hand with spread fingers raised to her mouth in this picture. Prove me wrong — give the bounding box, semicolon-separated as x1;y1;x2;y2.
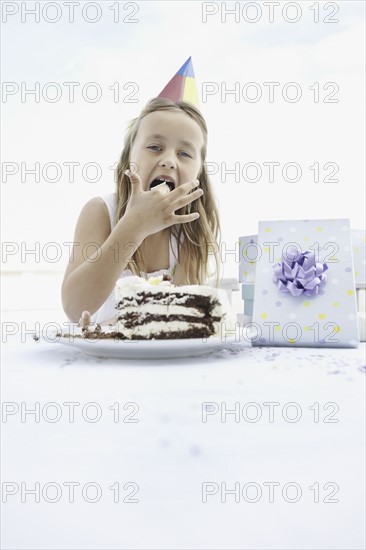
125;170;203;237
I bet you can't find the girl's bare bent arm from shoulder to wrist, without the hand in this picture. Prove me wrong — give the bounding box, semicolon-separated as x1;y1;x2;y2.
61;197;144;322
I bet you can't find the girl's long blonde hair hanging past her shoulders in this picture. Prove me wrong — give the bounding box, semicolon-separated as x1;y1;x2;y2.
116;98;220;284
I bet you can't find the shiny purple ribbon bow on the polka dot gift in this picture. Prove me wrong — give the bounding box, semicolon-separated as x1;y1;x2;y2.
273;247;328;296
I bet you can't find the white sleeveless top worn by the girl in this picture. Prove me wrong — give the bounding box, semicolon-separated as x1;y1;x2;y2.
92;193;178;323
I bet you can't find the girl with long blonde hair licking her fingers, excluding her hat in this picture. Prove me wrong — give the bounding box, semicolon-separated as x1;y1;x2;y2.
62;98;220;325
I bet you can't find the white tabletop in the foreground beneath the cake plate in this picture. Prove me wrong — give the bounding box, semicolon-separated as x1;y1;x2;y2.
1;311;365;550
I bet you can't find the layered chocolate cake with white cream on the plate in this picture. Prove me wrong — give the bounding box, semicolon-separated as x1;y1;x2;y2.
83;275;225;340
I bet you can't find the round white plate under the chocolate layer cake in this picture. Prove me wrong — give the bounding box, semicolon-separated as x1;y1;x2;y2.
56;335;244;359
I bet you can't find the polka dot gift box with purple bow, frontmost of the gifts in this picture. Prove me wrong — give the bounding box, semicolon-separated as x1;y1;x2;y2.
252;219;359;348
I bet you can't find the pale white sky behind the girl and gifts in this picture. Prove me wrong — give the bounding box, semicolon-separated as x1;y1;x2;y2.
2;0;365;277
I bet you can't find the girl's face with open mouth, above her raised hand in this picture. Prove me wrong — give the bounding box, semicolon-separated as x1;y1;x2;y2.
130;111;204;191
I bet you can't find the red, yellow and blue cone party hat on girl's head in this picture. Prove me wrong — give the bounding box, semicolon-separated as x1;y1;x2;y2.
158;57;199;108
